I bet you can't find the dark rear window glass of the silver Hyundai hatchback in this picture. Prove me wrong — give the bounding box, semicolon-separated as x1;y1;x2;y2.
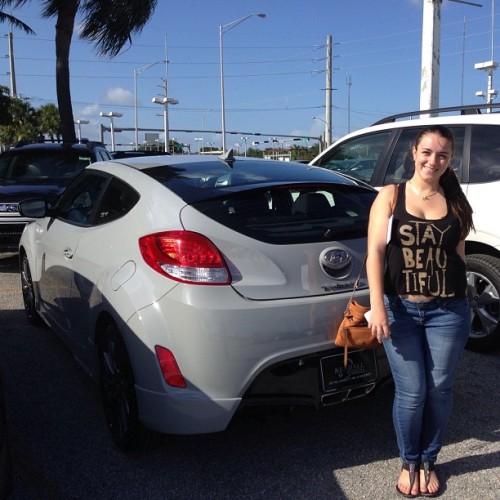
193;184;376;245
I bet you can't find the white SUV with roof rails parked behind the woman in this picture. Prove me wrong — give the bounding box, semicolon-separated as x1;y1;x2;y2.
310;104;500;351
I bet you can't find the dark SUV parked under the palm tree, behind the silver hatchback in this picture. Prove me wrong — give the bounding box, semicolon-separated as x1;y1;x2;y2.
0;143;112;252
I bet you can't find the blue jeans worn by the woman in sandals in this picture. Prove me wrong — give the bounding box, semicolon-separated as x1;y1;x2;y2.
383;296;470;462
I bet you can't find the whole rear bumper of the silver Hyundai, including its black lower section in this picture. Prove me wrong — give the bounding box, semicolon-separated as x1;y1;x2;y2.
122;286;390;434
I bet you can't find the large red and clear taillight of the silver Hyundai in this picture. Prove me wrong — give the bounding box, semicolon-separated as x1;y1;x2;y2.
139;231;231;285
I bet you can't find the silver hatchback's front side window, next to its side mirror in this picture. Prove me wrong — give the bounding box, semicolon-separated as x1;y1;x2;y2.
58;174;108;226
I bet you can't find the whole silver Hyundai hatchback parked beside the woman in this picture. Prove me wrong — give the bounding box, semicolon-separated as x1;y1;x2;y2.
20;155;390;449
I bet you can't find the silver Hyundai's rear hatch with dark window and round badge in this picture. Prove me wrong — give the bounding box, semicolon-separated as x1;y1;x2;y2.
181;183;375;300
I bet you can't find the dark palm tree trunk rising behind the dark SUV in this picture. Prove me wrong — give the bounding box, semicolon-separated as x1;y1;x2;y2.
56;0;78;143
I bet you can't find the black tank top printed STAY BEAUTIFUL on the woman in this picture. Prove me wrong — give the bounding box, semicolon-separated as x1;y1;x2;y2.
384;186;467;298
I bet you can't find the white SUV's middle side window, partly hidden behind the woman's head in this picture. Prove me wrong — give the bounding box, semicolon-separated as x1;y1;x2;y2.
384;127;465;185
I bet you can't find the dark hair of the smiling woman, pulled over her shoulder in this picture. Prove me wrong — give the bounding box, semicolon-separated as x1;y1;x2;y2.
415;125;474;239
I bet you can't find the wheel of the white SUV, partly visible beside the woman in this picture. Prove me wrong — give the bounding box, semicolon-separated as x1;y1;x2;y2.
466;254;500;352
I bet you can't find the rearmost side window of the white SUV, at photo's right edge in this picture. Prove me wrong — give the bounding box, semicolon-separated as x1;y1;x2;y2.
469;125;500;183
